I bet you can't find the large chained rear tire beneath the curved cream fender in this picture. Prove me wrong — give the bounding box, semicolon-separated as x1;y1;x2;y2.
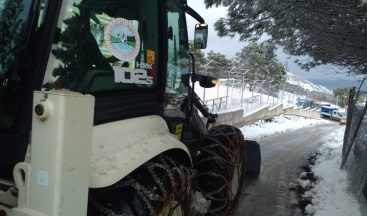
88;155;192;216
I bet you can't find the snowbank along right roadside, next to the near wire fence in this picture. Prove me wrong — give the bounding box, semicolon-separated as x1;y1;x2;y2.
303;127;361;216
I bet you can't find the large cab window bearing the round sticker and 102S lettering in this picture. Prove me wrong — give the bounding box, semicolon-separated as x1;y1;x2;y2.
44;0;159;93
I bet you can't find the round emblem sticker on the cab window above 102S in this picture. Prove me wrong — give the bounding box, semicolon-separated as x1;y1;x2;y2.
104;18;140;61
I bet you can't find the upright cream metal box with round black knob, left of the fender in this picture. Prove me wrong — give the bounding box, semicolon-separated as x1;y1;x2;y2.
10;91;94;216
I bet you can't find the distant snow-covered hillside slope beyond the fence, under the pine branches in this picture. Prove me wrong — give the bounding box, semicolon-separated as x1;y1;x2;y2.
282;72;335;102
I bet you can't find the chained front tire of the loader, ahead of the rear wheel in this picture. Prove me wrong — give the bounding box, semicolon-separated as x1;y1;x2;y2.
198;125;245;216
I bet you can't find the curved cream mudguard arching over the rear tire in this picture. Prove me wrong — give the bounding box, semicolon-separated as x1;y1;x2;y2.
89;116;191;188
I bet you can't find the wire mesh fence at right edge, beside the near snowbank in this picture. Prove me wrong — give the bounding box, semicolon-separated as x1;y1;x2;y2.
341;89;367;215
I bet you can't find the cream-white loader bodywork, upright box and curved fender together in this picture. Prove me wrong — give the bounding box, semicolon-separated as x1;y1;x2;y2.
4;91;191;216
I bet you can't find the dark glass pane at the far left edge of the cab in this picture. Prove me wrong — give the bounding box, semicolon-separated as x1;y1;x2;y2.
0;0;32;134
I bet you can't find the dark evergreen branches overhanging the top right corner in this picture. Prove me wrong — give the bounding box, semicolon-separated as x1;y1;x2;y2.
205;0;367;74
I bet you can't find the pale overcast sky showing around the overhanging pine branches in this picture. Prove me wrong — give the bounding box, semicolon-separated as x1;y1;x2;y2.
187;0;364;88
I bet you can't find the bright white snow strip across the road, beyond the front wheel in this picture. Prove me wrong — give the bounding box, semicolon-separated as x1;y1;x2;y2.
241;115;330;139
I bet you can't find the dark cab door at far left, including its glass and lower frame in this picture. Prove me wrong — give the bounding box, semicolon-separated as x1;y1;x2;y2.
0;0;51;180
